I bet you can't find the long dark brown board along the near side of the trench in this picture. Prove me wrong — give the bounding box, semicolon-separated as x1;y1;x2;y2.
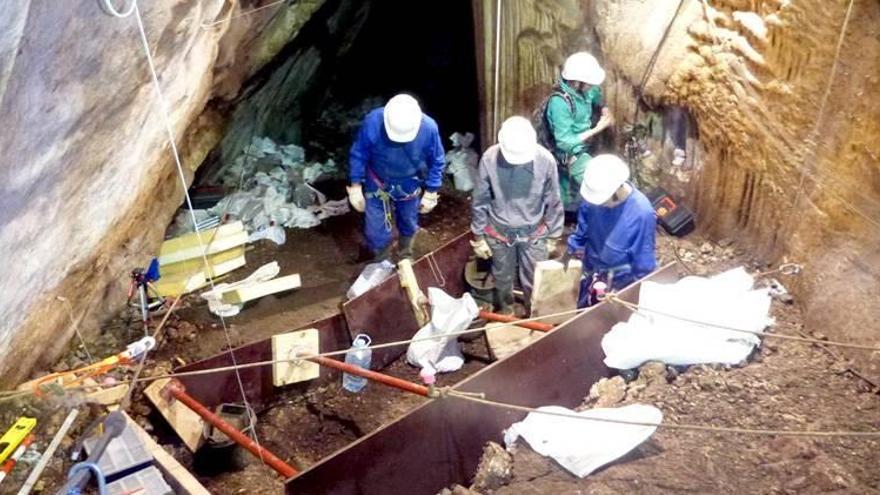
285;265;680;495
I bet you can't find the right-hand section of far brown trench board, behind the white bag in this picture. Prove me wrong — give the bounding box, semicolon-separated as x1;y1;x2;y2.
342;234;471;369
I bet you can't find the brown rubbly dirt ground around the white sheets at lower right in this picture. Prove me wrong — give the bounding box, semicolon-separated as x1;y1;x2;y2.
450;238;880;495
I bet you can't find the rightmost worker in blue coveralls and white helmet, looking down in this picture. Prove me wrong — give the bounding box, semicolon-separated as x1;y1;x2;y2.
562;154;657;308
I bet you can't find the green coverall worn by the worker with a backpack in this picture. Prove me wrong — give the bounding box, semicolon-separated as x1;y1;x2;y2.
547;80;602;211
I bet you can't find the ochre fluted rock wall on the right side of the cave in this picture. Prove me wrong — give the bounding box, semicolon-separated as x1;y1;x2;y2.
474;0;880;378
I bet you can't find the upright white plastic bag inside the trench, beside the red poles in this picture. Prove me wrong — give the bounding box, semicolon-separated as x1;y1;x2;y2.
406;287;480;373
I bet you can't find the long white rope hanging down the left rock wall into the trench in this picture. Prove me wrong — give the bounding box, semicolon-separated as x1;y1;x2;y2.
132;0;265;463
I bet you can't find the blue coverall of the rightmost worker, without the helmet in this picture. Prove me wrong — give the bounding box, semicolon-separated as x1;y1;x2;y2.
568;184;657;308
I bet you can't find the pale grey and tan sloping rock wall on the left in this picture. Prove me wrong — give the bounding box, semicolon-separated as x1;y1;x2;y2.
0;0;348;385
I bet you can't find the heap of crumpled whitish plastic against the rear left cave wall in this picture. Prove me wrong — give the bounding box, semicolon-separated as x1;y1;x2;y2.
208;137;348;239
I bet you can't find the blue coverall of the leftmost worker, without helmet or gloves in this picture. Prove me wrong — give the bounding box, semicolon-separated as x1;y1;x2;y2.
349;107;446;253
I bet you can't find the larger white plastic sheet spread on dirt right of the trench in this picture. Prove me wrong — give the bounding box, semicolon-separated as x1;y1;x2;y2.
602;267;773;369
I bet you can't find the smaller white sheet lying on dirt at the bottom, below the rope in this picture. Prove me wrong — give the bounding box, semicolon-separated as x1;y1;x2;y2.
504;404;663;478
